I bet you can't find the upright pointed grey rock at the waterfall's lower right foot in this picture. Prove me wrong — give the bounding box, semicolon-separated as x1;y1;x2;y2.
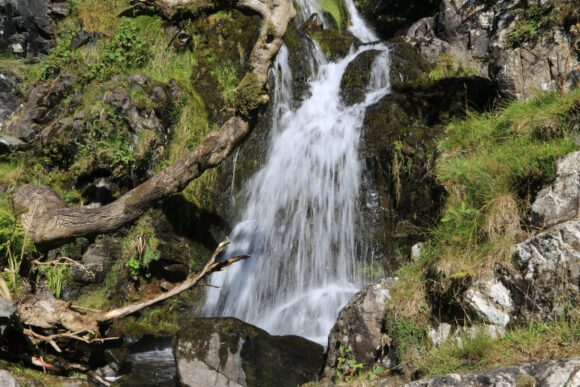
324;278;397;376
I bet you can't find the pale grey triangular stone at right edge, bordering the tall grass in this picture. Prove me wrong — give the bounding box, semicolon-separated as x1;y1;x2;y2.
531;151;580;228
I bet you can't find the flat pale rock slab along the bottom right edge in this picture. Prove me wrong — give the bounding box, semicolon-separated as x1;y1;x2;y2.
406;358;580;387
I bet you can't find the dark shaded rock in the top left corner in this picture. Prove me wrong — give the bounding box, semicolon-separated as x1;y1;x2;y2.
0;0;70;57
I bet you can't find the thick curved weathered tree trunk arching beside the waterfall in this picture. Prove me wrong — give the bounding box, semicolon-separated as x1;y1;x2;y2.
13;0;295;246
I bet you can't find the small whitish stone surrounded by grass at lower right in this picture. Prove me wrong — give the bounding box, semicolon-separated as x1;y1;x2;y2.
463;278;514;327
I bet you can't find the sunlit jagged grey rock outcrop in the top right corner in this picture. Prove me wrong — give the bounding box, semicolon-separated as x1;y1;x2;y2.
406;0;579;99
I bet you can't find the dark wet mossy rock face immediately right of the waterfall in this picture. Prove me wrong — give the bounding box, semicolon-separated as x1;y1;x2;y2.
360;77;497;270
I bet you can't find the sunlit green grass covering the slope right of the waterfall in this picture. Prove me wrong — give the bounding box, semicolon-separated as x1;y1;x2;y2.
386;90;580;375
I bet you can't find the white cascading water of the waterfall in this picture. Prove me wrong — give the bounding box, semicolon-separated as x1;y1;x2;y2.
204;0;389;344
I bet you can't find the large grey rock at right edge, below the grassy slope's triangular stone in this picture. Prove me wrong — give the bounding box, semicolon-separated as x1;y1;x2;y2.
504;219;580;321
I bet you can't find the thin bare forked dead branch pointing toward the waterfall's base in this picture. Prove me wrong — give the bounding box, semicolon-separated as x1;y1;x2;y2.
97;238;250;323
